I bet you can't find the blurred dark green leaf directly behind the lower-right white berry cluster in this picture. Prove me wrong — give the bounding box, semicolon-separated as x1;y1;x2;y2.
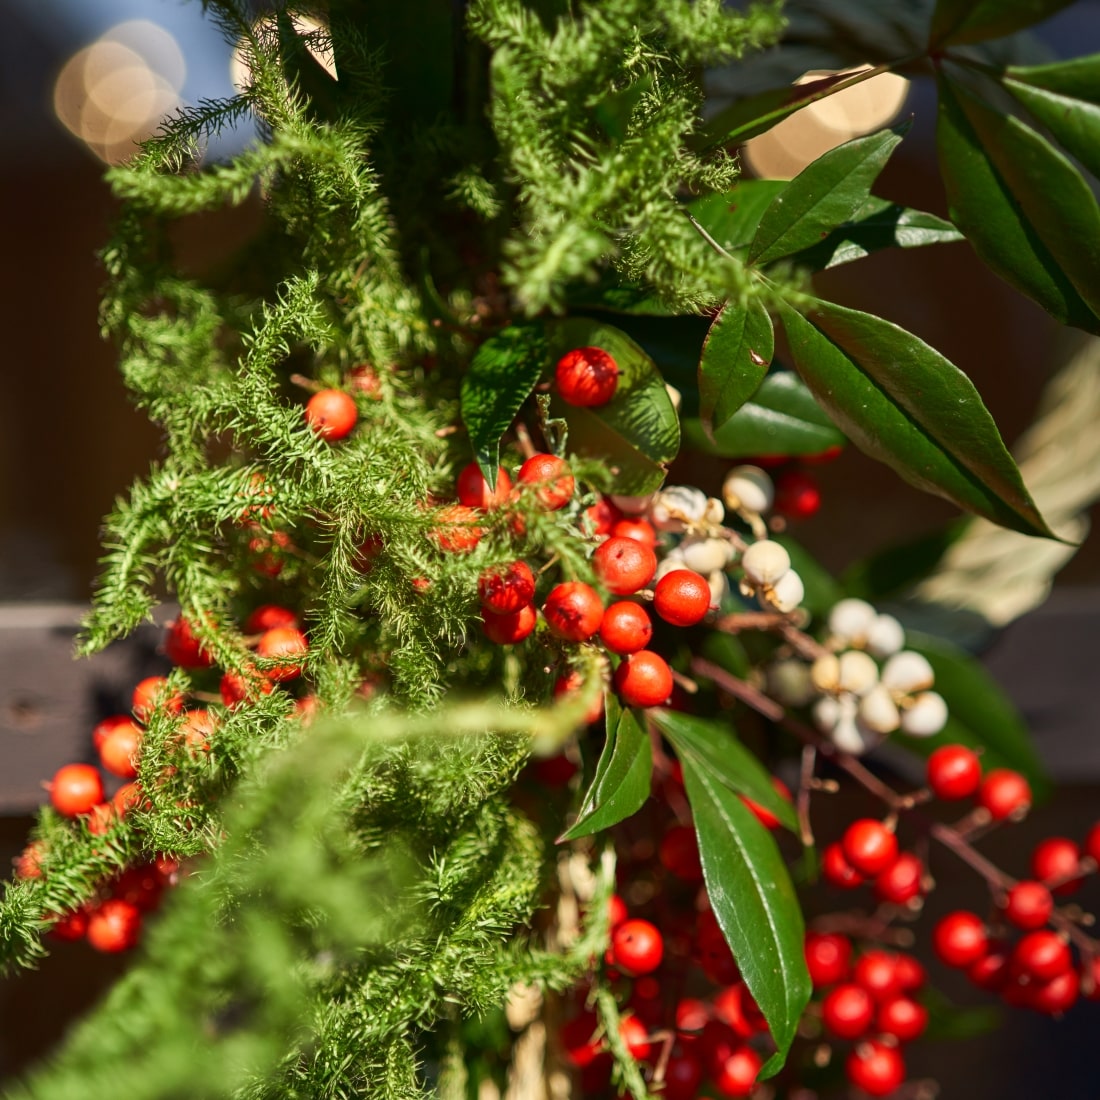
902;630;1051;799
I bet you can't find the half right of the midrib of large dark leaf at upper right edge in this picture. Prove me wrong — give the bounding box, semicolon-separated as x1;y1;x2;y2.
953;70;1100;321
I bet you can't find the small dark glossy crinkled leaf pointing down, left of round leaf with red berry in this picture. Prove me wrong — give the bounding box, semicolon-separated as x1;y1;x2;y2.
462;325;548;485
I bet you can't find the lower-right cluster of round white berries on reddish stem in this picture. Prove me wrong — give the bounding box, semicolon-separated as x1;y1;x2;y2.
758;598;947;754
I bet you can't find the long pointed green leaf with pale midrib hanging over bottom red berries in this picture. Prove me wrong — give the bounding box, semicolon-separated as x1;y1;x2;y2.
681;754;812;1077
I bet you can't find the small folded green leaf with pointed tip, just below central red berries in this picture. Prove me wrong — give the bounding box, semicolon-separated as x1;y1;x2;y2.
558;694;653;842
